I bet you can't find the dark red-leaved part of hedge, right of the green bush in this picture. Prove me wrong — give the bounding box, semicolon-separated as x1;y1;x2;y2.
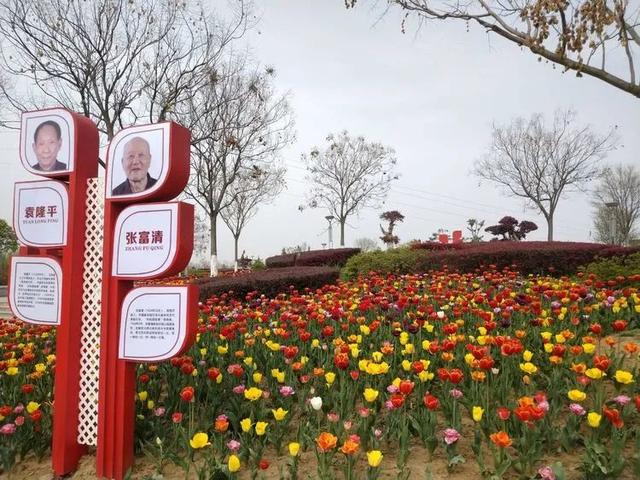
428;242;640;275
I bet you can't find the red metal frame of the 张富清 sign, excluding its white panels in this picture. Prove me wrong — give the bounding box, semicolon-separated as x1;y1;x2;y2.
96;123;197;480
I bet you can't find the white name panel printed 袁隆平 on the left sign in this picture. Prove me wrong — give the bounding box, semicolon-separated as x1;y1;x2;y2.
13;180;69;247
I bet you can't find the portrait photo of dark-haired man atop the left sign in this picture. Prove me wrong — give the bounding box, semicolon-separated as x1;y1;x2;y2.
22;114;73;175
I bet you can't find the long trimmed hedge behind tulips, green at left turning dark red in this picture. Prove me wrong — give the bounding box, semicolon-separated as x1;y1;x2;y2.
342;242;640;278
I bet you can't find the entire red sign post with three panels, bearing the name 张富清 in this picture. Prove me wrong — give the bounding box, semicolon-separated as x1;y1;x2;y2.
96;123;198;479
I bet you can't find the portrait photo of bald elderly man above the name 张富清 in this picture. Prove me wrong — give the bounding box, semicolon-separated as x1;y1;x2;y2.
109;129;164;196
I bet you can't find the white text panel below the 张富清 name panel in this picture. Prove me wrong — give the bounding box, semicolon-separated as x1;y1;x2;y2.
119;287;188;362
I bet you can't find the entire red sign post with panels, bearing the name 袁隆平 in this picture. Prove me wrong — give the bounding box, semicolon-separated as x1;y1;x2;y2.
9;108;99;475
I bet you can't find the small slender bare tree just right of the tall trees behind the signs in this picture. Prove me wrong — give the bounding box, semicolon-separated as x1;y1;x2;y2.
220;166;286;265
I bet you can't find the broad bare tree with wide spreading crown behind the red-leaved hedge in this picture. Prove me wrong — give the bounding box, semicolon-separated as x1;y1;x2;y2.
474;111;615;241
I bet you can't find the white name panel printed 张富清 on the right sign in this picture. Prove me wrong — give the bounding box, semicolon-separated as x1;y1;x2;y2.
112;203;178;278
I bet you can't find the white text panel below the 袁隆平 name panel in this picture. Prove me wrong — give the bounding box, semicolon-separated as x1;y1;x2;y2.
9;257;62;325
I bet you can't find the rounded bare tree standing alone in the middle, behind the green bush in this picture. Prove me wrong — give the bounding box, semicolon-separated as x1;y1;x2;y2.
302;130;398;246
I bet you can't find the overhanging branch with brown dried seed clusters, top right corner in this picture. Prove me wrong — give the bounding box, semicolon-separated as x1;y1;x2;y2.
345;0;640;97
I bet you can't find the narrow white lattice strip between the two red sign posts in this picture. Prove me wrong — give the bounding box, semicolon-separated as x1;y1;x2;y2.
78;178;104;445
